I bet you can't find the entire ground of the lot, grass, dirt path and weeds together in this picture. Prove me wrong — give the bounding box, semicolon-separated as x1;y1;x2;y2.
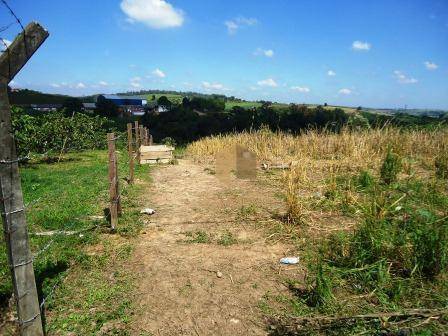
1;128;448;335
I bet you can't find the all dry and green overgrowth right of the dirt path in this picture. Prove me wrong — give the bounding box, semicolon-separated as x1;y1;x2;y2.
186;127;448;335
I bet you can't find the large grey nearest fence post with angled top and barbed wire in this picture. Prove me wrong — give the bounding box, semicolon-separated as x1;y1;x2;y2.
0;22;48;336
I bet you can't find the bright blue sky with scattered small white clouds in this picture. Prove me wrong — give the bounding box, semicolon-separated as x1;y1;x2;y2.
0;0;448;109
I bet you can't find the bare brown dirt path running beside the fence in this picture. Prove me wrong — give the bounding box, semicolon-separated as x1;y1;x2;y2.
133;160;301;335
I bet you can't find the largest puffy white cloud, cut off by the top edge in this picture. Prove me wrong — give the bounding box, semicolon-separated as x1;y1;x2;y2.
120;0;184;29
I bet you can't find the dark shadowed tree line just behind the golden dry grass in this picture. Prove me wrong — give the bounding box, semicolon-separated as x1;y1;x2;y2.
141;98;349;143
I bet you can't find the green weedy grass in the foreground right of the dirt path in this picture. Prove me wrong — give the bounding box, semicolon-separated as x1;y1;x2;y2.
263;155;448;335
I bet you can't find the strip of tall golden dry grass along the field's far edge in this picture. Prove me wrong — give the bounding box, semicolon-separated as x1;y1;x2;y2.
187;127;448;170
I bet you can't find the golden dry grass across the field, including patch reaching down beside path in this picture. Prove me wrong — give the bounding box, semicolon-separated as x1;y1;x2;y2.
186;127;448;231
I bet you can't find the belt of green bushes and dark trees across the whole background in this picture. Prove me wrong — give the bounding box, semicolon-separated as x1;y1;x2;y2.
8;89;448;152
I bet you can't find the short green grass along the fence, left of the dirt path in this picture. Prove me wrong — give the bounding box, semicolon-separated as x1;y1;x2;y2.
0;150;149;335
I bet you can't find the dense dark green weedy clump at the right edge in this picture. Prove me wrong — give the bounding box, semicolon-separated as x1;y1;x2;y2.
326;192;448;279
